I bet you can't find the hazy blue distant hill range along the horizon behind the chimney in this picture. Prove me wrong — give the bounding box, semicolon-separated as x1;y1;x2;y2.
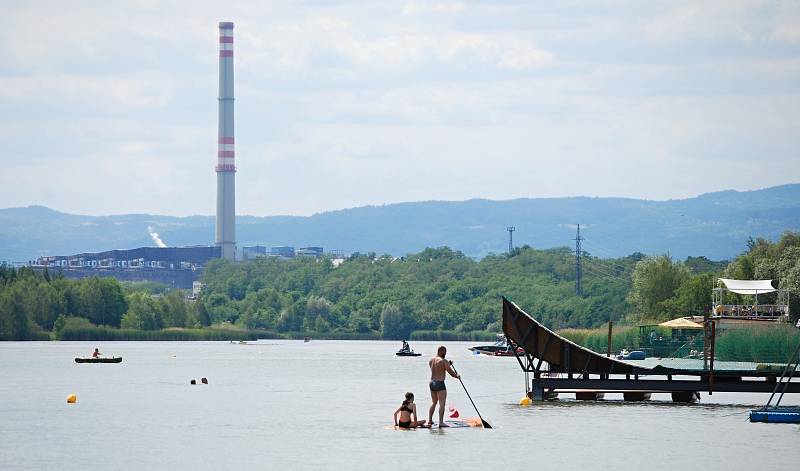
0;184;800;261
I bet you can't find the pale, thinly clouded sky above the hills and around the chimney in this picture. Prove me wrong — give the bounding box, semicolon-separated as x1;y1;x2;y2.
0;0;800;216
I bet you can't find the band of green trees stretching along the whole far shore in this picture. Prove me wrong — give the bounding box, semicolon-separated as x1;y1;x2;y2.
0;232;800;340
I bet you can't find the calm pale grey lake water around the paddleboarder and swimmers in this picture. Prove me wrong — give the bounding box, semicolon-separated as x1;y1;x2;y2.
0;340;800;471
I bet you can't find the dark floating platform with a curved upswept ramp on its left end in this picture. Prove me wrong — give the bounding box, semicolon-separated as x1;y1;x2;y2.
503;298;800;402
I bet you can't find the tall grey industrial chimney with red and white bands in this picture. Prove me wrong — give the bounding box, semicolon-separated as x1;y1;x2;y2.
216;22;236;260
